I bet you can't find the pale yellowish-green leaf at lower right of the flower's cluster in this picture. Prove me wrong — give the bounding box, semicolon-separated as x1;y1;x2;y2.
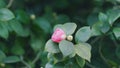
75;43;91;62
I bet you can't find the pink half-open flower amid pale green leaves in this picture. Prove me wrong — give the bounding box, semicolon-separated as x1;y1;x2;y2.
51;28;66;43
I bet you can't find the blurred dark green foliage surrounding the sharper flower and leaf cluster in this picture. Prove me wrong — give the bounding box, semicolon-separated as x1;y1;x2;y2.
0;0;120;68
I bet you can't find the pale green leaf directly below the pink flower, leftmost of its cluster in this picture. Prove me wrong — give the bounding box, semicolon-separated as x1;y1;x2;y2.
45;39;60;53
